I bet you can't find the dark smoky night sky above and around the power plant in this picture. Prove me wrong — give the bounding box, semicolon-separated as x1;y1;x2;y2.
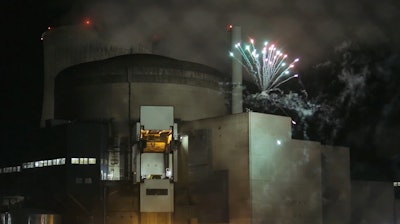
0;0;400;178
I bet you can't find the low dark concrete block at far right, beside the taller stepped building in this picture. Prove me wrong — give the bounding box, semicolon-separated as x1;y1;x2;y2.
351;181;395;224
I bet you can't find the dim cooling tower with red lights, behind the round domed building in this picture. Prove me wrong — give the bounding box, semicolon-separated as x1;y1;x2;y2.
41;24;151;125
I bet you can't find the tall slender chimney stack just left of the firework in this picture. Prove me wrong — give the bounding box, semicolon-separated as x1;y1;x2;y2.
229;25;243;114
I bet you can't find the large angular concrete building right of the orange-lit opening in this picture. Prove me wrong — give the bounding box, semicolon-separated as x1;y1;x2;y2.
180;112;350;224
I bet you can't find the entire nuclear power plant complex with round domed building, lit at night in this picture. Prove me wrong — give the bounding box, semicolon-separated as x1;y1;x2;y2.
0;21;394;224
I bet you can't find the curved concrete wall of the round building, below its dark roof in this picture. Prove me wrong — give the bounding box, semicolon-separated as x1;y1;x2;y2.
55;83;227;136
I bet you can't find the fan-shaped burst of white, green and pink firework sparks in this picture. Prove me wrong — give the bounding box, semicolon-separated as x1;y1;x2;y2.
230;39;299;92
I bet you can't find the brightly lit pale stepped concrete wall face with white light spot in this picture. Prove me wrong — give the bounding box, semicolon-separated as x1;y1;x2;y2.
250;113;322;224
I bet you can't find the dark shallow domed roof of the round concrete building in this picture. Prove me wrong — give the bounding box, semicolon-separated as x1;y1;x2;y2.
56;54;228;88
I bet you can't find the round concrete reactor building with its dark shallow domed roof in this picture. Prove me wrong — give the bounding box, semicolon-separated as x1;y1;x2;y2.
55;54;229;133
